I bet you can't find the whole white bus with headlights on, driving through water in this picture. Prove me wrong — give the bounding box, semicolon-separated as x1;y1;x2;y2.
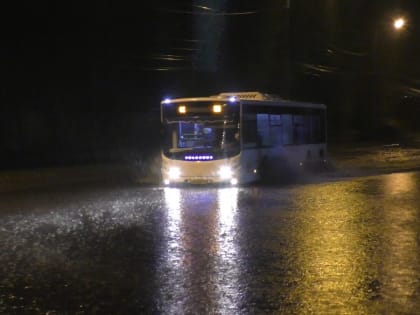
161;92;327;185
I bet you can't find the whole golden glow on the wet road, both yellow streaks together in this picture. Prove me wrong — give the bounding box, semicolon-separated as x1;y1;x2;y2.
293;173;420;314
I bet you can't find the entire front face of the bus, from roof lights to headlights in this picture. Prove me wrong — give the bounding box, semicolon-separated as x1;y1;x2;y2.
161;97;240;185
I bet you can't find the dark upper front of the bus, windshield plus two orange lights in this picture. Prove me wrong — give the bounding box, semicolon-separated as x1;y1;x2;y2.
162;100;240;160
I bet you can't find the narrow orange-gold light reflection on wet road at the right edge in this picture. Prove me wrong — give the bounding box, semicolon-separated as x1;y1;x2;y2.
381;173;420;312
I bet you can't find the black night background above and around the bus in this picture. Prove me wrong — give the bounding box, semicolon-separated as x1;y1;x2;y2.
0;0;420;169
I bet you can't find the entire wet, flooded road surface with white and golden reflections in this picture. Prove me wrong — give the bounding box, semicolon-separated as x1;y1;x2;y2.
0;172;420;314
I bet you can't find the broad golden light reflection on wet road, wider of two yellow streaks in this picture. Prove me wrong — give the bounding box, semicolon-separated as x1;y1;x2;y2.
294;183;374;314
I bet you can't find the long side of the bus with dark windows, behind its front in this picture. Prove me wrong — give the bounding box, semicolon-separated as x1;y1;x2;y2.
241;99;327;182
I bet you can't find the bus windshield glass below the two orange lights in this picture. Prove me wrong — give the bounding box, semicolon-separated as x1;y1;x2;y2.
164;120;239;159
